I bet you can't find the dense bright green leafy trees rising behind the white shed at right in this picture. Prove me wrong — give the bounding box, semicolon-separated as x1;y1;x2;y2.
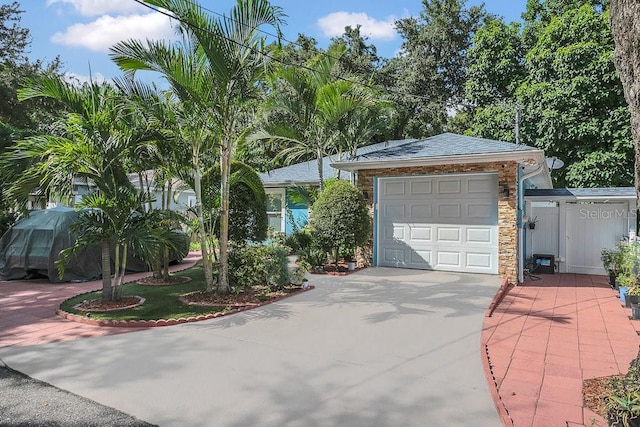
465;0;632;187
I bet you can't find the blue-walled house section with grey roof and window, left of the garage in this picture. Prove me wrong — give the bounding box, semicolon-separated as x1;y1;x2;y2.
260;139;416;234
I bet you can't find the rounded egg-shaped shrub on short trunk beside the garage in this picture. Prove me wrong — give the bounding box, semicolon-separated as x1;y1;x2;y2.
311;180;370;263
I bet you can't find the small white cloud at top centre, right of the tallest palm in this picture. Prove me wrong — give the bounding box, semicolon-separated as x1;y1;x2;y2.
318;12;396;40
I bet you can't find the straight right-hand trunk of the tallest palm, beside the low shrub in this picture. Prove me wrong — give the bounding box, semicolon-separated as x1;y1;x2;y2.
218;138;231;294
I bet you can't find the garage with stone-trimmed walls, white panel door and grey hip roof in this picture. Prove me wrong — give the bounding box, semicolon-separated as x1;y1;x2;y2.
332;133;552;283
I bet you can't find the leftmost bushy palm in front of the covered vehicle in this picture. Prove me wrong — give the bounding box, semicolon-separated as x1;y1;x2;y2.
3;77;162;299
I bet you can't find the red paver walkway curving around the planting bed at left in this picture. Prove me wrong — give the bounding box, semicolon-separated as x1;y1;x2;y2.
0;252;200;347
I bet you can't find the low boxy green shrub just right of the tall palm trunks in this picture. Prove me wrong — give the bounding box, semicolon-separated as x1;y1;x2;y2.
229;243;289;290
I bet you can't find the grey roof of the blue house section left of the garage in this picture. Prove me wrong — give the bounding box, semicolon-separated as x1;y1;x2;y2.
260;139;416;186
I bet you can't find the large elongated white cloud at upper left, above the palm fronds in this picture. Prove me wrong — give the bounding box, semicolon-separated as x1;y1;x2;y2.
51;13;174;51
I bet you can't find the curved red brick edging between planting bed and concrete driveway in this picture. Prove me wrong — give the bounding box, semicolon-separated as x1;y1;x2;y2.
56;285;315;328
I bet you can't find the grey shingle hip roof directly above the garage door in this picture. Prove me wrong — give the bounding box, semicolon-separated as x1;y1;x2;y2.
344;133;537;162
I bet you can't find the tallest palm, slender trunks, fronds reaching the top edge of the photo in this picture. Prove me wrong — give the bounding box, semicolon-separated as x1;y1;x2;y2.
111;0;283;293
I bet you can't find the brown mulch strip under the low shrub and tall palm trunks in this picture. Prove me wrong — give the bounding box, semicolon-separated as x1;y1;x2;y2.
180;285;306;308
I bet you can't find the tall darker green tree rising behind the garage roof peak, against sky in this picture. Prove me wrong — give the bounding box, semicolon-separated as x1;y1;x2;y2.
383;0;486;137
